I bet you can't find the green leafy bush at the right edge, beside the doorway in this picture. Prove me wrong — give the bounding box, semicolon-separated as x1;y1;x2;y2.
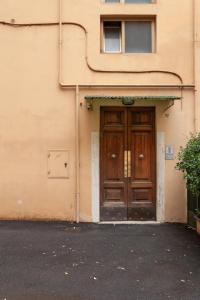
176;133;200;233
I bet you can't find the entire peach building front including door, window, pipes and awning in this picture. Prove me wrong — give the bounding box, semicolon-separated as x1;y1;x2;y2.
0;0;200;222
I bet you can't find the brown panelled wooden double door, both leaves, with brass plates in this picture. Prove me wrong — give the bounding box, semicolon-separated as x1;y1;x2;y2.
100;107;156;221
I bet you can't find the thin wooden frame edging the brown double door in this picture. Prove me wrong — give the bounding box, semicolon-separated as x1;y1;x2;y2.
99;106;158;222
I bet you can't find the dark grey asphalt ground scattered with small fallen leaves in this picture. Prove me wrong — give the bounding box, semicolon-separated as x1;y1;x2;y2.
0;221;200;300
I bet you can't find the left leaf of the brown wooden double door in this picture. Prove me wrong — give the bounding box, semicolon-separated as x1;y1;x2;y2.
100;107;127;221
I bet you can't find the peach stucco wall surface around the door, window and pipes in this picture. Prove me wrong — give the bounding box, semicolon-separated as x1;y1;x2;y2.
0;0;200;222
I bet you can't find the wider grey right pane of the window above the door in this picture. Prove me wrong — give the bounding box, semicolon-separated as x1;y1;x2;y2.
125;21;152;53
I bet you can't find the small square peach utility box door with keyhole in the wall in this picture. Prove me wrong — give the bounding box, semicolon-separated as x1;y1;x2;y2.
47;150;69;178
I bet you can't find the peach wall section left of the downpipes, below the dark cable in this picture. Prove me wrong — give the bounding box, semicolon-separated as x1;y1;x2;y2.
0;27;75;220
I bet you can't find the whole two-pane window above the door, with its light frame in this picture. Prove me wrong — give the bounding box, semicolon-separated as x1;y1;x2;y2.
102;19;155;53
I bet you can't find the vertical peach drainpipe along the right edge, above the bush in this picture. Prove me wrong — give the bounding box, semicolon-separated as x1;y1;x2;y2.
193;0;200;132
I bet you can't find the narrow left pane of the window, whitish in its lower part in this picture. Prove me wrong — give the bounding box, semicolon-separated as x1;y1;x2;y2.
104;22;121;52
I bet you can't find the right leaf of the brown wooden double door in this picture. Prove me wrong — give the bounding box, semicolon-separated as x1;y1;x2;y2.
128;108;156;221
